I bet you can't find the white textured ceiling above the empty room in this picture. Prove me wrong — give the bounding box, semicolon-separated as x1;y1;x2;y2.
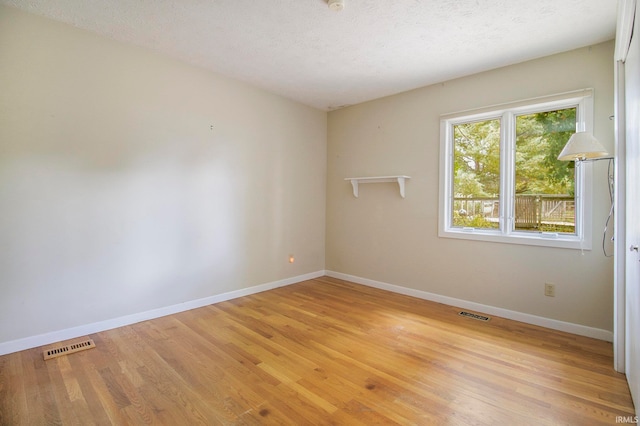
0;0;617;110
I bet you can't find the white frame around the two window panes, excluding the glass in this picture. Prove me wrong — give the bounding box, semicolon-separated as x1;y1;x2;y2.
438;89;593;250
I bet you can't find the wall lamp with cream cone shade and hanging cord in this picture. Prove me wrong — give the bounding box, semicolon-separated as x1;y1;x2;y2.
558;132;614;257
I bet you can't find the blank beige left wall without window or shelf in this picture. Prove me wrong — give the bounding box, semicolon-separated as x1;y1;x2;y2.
0;7;326;343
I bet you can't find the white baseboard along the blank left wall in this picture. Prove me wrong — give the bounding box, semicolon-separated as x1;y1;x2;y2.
0;271;325;355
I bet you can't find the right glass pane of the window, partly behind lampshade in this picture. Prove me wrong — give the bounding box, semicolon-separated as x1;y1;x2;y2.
514;108;576;234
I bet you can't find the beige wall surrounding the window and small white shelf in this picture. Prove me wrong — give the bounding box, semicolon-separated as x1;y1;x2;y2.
326;42;614;331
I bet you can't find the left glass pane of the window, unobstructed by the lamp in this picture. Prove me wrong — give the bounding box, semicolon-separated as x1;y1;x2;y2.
451;119;500;229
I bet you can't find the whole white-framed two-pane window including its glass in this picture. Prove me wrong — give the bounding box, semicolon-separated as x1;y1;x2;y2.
439;89;593;249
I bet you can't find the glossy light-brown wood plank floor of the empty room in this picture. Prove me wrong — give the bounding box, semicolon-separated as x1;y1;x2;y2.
0;277;634;425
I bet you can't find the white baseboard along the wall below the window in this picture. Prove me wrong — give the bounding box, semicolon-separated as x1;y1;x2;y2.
325;271;613;342
